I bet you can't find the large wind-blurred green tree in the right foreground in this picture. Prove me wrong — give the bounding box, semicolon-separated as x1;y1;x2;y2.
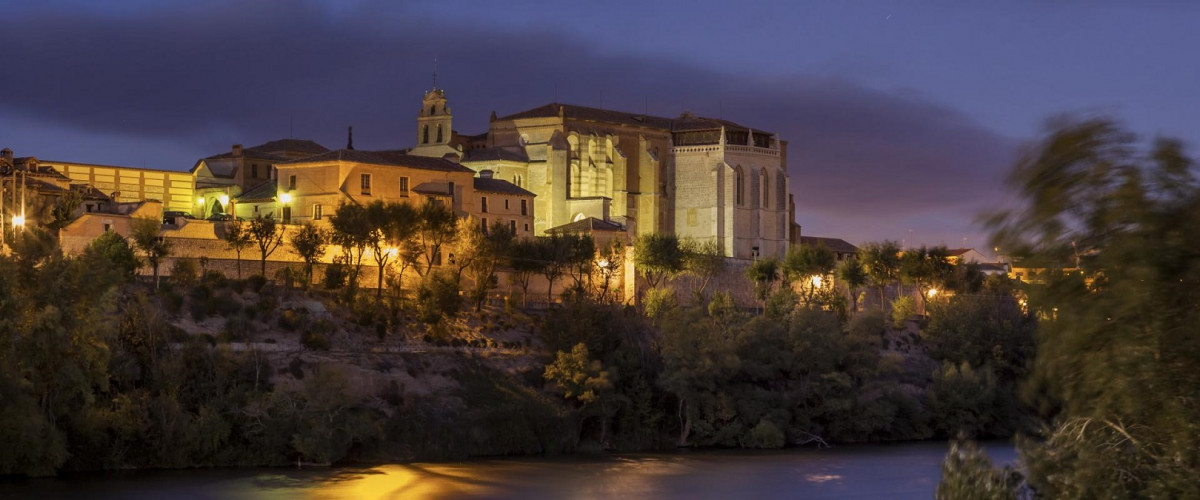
988;119;1200;498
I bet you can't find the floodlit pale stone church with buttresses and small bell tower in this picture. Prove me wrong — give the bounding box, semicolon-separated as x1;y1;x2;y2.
409;89;794;259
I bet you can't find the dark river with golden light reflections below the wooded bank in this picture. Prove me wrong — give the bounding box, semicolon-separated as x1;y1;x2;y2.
0;442;1016;500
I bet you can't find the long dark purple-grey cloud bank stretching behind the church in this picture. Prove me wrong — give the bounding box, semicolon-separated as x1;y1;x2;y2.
0;2;1013;241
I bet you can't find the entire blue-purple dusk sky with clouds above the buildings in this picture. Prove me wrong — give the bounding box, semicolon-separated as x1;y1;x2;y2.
0;0;1200;248
